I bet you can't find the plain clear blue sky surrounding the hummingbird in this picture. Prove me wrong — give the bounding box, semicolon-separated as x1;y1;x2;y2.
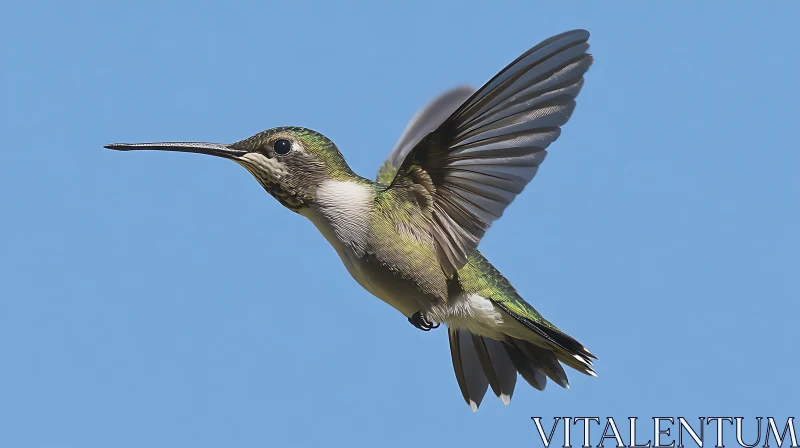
0;1;800;448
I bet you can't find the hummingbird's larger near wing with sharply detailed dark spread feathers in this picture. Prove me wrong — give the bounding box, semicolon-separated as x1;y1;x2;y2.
390;30;592;275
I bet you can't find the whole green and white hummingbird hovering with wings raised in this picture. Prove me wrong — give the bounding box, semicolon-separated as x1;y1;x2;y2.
106;30;597;411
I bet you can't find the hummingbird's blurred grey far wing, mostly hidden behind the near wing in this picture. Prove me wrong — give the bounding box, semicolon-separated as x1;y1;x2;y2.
375;86;475;185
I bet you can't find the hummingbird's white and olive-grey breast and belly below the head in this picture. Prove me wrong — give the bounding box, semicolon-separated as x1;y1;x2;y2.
300;180;447;317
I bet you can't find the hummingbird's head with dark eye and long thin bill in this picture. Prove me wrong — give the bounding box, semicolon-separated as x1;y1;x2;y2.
106;127;356;212
